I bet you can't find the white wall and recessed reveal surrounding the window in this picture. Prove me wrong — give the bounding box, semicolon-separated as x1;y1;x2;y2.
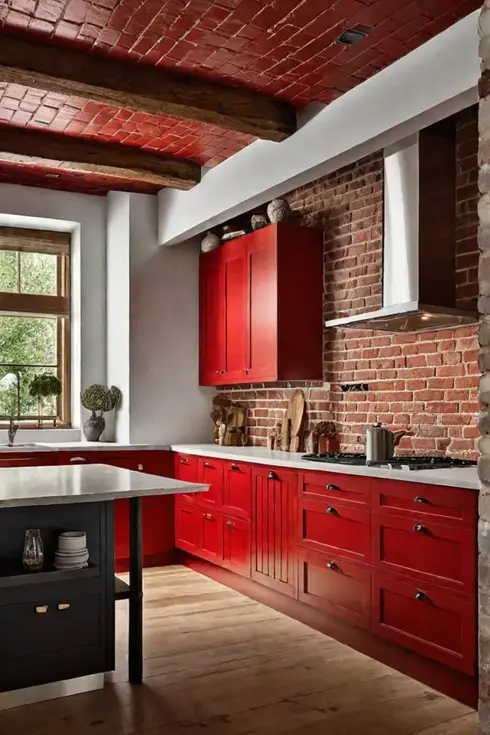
0;184;106;442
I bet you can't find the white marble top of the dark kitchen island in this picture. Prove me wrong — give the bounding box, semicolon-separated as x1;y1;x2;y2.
0;464;209;508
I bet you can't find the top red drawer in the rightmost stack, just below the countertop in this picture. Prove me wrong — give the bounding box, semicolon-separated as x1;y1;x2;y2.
373;478;478;528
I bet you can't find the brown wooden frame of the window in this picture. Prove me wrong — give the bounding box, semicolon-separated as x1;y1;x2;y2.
0;226;71;429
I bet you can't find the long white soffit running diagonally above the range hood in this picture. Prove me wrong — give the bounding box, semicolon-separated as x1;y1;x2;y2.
158;11;480;245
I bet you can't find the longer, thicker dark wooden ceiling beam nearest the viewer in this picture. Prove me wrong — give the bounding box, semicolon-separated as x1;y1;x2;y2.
0;34;296;141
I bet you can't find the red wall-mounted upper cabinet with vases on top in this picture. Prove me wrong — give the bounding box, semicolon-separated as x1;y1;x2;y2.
200;223;323;385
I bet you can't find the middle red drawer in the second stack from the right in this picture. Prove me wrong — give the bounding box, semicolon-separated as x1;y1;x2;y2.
298;498;371;563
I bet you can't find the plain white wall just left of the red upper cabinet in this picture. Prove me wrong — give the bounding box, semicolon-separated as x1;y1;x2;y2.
130;194;214;444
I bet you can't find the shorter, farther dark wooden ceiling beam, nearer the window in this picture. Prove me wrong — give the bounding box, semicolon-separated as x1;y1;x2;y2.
0;125;201;189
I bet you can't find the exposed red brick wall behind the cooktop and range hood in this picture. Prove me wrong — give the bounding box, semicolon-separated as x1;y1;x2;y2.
218;108;479;457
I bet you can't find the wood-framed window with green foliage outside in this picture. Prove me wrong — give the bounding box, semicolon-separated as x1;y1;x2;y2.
0;227;70;427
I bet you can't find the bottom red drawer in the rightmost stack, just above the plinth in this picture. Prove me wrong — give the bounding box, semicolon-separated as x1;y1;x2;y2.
372;570;476;676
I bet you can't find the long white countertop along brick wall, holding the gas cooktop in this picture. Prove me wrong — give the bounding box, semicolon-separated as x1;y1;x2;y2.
171;444;480;490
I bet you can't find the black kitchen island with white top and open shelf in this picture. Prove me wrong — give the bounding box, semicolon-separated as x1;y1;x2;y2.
0;464;207;703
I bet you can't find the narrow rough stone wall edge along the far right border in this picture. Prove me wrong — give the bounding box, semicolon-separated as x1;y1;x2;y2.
478;0;490;734
